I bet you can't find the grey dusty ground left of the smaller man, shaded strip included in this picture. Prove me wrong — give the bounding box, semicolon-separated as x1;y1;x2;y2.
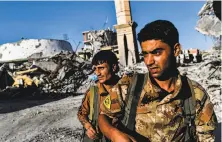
0;96;83;142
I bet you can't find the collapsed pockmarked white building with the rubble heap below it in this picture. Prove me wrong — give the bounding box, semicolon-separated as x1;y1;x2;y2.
0;39;92;97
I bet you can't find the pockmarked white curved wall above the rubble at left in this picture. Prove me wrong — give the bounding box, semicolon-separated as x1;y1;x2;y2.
0;39;73;62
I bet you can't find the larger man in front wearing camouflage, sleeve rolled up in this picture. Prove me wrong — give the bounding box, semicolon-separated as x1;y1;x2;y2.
99;20;217;142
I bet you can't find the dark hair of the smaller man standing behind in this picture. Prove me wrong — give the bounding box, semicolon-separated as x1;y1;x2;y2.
92;50;119;72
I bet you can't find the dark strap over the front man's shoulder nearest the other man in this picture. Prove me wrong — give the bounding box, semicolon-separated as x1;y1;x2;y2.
122;74;148;131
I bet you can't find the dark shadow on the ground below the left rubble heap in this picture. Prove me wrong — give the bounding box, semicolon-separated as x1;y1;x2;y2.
0;88;80;114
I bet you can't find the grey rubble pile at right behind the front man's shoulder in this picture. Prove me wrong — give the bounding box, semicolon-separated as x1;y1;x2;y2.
178;50;222;122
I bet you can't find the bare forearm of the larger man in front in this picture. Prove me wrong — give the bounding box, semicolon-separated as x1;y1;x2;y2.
98;114;136;142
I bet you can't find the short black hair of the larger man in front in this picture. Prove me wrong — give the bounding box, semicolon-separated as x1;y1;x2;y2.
138;20;179;47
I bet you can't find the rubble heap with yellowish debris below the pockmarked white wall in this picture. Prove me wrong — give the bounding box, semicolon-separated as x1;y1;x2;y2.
0;51;92;98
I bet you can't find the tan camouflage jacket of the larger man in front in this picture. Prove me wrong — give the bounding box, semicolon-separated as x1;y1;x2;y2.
101;75;217;142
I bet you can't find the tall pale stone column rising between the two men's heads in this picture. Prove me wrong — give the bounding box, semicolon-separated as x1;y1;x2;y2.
114;0;139;67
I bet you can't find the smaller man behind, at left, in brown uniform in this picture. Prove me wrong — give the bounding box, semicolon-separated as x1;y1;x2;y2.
77;51;131;141
